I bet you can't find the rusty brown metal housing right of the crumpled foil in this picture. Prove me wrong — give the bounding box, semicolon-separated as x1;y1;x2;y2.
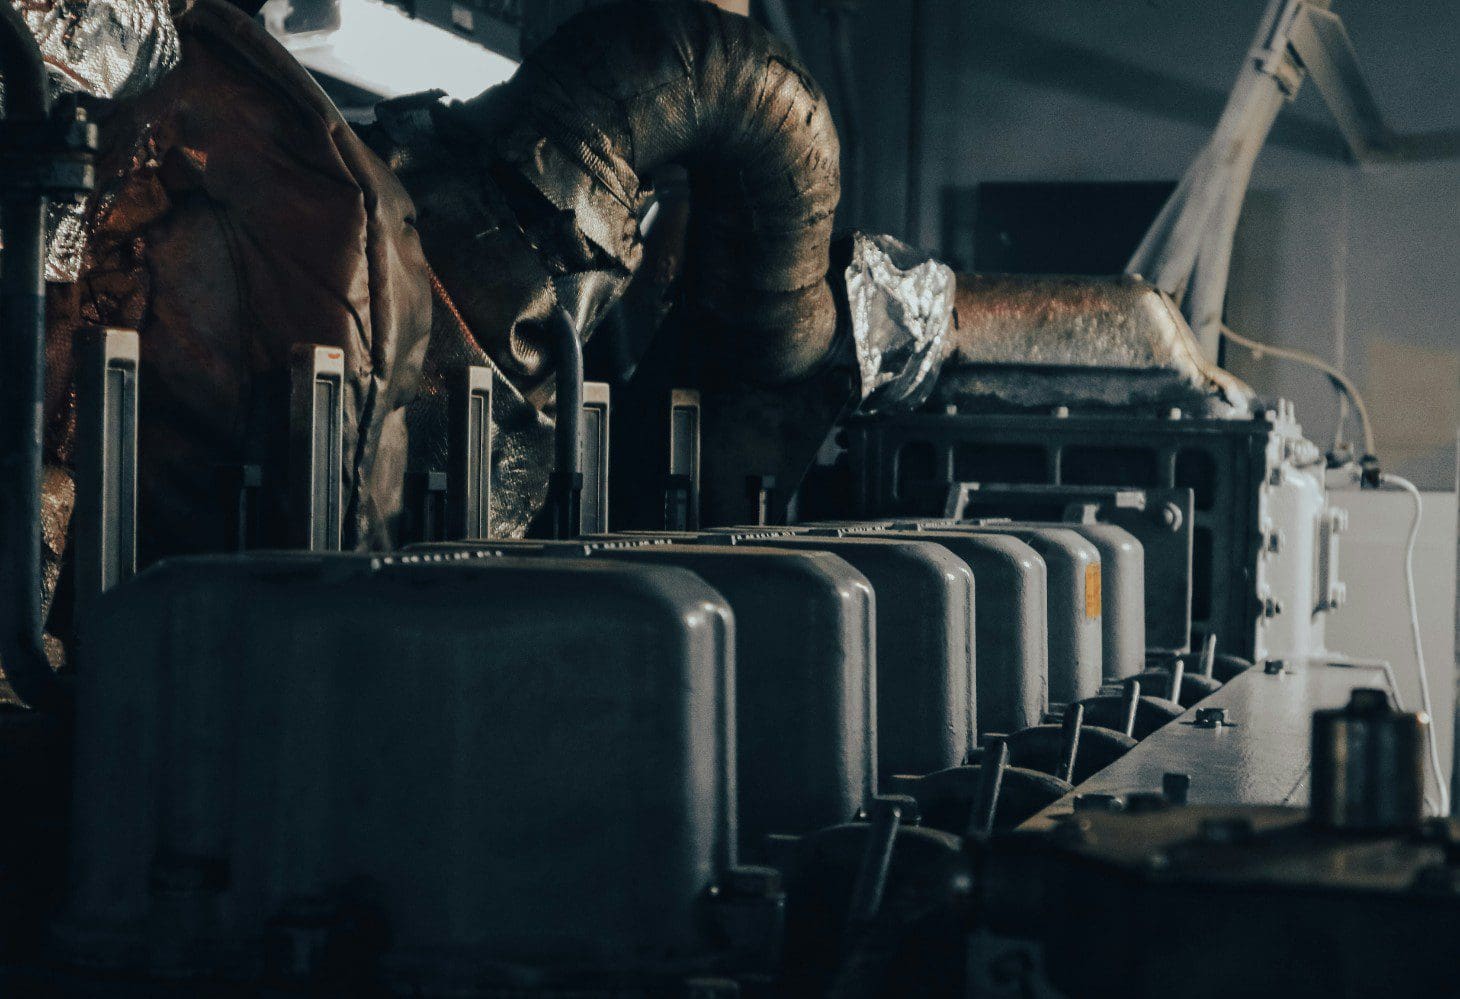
936;275;1253;418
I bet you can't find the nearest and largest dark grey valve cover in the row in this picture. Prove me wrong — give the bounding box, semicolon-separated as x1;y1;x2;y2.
57;554;736;995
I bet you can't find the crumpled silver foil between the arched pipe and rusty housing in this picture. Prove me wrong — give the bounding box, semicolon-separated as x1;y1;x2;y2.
847;232;956;412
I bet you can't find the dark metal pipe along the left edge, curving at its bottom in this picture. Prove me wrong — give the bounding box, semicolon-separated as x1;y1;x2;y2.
0;3;70;710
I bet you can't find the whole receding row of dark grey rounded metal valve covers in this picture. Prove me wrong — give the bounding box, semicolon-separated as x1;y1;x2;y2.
60;526;1115;987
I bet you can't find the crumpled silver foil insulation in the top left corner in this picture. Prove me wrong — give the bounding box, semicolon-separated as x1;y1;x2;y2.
0;0;183;282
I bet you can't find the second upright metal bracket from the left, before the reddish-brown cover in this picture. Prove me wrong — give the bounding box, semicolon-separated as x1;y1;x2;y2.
289;343;345;552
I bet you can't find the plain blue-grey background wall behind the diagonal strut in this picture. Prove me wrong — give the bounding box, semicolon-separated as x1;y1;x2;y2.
790;0;1460;489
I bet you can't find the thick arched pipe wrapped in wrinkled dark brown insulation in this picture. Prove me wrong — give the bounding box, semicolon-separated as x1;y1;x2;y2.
446;1;841;383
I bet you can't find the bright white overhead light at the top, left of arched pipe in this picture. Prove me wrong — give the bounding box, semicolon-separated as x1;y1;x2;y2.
261;0;517;99
